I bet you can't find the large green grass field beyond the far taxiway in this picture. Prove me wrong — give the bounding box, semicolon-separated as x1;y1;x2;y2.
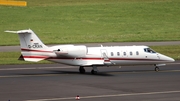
0;0;180;45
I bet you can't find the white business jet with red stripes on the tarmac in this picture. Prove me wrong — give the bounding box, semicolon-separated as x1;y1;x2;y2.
5;29;175;74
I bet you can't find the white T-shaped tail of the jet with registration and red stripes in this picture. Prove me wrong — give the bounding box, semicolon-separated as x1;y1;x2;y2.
5;29;52;62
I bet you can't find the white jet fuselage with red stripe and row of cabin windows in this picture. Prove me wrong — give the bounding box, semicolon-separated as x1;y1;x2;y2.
47;46;174;66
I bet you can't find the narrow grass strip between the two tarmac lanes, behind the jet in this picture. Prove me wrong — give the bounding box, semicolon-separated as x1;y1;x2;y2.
0;45;180;65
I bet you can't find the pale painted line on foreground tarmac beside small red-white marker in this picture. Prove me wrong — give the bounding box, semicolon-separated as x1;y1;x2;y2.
25;91;180;101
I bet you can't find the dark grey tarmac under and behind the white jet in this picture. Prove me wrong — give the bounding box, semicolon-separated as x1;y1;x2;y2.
0;41;180;101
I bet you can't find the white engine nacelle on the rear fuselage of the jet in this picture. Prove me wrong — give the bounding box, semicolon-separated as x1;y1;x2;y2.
55;46;88;58
